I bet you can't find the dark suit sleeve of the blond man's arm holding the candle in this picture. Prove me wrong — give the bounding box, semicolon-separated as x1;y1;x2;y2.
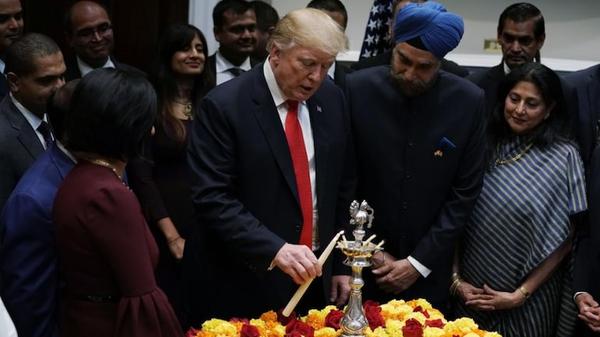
188;97;285;270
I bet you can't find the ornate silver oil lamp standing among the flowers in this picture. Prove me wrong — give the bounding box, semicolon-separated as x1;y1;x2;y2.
337;200;383;337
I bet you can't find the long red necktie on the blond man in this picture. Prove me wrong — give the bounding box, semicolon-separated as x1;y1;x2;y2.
285;101;313;249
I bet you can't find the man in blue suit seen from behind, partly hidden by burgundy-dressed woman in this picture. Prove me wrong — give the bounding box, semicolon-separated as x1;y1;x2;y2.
0;80;78;337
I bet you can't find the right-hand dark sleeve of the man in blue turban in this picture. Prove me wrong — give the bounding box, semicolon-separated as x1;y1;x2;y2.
411;91;485;269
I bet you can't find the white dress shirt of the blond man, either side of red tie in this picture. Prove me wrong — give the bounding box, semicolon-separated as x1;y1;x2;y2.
263;59;320;250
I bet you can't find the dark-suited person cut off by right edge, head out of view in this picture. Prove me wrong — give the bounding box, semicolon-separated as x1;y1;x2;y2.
565;65;600;336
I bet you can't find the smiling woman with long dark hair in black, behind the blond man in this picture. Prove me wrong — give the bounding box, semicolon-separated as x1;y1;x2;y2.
127;24;214;322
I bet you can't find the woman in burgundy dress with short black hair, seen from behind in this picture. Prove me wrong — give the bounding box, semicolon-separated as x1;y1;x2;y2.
53;69;183;337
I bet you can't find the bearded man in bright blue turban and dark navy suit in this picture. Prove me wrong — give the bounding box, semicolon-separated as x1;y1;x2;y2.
346;1;484;310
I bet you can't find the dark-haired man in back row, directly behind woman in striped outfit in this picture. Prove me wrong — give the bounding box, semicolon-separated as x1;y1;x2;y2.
468;2;546;115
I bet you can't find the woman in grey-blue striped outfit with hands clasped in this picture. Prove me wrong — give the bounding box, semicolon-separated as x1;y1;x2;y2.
451;63;587;337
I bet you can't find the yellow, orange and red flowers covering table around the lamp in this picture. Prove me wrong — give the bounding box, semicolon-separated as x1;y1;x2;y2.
187;299;501;337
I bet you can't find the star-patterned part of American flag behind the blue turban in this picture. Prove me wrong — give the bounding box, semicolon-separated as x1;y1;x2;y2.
360;0;393;59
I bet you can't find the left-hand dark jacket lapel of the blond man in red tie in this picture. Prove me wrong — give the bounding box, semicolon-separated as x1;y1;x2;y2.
252;67;300;204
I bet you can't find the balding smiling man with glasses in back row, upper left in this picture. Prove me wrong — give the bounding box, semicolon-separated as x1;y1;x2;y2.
65;1;142;81
